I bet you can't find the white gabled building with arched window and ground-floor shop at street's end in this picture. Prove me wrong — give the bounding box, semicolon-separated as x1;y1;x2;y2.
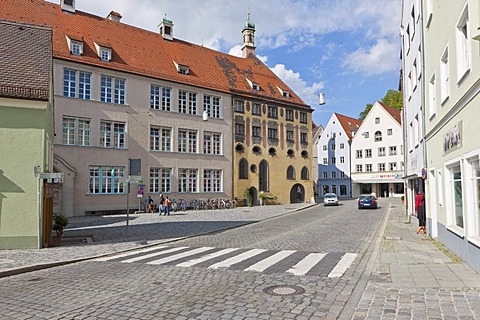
351;101;404;197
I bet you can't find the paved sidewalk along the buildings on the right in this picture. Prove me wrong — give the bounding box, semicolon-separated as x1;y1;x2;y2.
352;202;480;319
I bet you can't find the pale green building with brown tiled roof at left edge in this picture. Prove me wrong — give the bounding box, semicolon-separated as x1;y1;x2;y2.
0;20;54;249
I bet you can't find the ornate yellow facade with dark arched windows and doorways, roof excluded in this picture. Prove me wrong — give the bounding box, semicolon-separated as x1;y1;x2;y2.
232;97;313;205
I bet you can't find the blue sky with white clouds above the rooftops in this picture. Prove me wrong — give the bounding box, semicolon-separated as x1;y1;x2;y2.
48;0;402;127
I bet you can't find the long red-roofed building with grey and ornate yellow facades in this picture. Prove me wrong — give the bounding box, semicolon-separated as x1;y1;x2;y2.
0;0;313;215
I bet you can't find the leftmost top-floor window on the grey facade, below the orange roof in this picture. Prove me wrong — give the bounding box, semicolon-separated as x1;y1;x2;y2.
63;69;92;100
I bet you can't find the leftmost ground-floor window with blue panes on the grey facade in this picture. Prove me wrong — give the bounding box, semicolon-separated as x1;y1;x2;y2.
88;166;125;194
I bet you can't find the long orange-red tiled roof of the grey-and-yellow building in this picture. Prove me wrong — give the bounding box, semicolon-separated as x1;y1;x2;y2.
0;0;312;110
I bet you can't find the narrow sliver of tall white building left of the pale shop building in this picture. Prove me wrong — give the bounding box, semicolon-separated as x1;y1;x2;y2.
401;0;428;216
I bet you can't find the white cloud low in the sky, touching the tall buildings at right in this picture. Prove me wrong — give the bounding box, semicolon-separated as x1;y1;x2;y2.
342;39;400;75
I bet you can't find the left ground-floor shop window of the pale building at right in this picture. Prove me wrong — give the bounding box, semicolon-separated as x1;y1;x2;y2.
448;163;464;229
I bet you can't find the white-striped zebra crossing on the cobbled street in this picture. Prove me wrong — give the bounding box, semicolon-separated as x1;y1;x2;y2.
94;246;357;278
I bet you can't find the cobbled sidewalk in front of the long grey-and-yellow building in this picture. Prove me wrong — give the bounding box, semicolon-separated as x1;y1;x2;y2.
0;203;315;278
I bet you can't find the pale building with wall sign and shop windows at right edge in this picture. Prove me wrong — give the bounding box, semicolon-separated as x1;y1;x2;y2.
422;0;480;271
